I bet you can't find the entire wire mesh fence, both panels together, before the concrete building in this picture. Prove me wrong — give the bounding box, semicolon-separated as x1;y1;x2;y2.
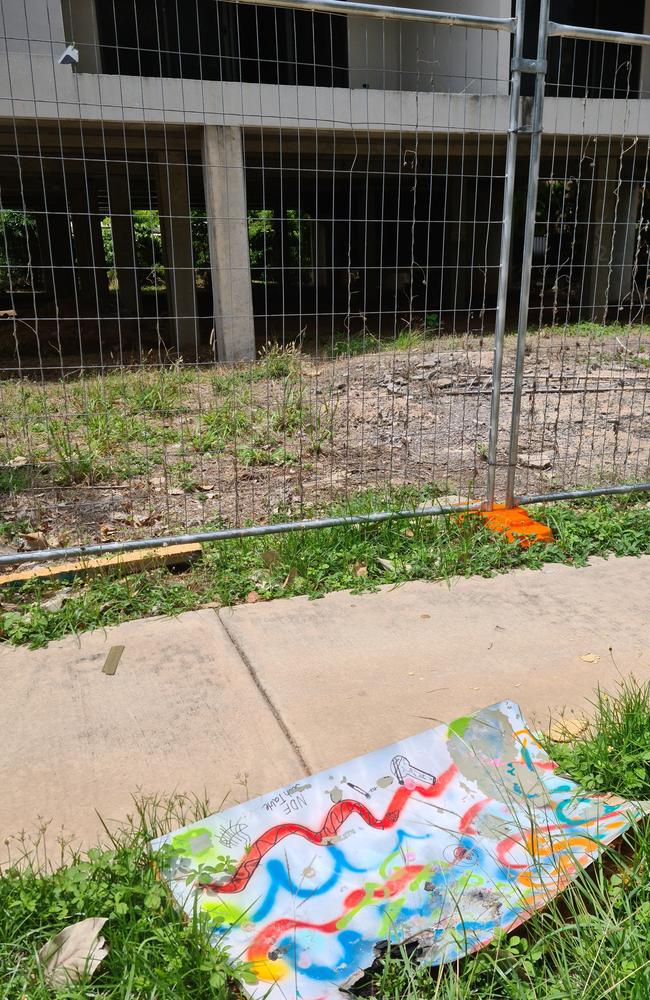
0;0;650;560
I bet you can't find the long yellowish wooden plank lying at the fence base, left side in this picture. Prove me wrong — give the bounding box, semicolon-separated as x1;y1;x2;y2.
0;543;202;587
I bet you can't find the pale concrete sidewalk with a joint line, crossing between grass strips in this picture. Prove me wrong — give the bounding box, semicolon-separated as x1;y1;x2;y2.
0;557;650;857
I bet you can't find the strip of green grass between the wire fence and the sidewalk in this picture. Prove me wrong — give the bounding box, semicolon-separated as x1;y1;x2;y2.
0;490;650;648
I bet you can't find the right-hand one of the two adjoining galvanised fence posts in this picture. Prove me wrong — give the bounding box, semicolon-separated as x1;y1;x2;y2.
506;0;550;507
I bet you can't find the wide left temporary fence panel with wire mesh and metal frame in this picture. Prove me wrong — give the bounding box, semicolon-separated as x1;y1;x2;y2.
0;0;515;564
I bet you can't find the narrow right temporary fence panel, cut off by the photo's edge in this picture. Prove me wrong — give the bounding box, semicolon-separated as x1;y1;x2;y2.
501;10;650;503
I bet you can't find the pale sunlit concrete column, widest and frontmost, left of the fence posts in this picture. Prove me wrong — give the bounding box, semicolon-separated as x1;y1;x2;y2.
203;125;255;362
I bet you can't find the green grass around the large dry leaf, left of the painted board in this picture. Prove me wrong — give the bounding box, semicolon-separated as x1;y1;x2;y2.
0;796;246;1000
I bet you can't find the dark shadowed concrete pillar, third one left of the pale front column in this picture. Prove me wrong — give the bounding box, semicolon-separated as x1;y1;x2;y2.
70;177;108;309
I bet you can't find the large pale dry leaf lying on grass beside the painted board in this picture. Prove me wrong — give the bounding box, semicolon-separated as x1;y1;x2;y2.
38;917;108;989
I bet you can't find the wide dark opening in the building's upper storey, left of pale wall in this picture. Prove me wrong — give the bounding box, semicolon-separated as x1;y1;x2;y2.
97;0;348;87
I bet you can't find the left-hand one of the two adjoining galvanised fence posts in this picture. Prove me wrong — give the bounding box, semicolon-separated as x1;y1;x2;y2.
485;0;526;510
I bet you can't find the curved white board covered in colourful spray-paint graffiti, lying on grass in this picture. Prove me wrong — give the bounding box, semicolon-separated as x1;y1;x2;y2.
153;701;635;1000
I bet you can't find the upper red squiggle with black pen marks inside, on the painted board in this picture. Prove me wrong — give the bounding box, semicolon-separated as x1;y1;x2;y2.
202;764;458;894
